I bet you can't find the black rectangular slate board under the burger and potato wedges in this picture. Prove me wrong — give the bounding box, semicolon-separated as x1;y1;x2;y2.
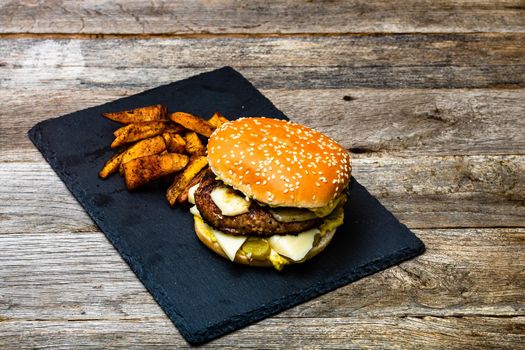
29;67;425;344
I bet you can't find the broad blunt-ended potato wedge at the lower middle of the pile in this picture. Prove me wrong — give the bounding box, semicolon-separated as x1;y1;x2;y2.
124;153;188;191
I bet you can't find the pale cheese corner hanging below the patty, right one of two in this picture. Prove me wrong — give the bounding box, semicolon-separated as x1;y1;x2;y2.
268;228;320;261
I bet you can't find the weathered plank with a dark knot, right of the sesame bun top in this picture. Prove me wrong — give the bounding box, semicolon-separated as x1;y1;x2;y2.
263;89;525;156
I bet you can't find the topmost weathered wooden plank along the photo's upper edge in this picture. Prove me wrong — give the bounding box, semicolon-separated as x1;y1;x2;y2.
0;0;525;34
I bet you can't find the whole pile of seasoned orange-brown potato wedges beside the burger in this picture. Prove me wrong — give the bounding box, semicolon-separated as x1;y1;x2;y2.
99;105;228;206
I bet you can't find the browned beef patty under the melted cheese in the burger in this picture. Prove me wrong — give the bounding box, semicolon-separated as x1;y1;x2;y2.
195;171;322;237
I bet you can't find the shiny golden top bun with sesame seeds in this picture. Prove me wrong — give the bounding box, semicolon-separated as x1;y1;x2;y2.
208;118;352;208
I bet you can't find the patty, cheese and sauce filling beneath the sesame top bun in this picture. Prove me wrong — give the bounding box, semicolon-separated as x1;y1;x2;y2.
189;172;346;270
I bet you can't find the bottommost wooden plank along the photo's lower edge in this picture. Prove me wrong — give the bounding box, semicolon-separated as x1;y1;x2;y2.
0;317;525;350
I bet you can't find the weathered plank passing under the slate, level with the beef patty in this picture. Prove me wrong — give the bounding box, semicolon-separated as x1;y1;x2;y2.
0;151;525;233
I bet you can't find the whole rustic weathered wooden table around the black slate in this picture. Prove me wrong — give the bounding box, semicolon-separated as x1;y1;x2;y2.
0;0;525;349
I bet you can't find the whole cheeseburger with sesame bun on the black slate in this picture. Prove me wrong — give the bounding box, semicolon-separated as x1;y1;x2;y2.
189;118;351;270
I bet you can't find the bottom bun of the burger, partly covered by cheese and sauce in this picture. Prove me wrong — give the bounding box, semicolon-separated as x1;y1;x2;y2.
195;216;336;267
